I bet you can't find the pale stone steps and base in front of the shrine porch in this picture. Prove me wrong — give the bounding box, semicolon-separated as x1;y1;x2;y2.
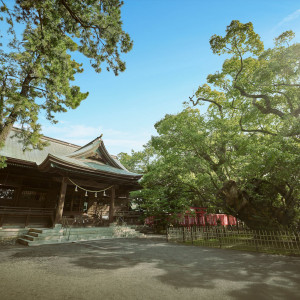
17;225;144;246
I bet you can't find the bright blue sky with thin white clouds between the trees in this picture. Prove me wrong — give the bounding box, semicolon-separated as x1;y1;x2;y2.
41;0;300;154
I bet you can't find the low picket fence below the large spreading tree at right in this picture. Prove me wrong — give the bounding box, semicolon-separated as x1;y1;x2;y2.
167;226;300;254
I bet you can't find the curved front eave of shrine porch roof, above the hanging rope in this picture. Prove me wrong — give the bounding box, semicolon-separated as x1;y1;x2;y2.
38;154;142;182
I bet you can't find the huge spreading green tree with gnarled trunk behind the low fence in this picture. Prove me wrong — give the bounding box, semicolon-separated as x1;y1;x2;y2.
130;21;300;229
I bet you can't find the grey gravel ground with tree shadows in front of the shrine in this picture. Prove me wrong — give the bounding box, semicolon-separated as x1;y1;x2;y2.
0;238;300;300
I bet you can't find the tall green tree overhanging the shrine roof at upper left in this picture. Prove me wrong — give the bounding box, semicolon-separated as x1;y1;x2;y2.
0;0;132;164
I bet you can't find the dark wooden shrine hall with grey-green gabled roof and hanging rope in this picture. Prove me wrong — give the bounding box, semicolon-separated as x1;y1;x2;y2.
0;128;141;228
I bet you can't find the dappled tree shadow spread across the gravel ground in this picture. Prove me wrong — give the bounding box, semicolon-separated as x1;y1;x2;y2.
4;239;300;299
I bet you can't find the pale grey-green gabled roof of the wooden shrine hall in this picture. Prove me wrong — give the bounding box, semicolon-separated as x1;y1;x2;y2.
0;128;141;179
